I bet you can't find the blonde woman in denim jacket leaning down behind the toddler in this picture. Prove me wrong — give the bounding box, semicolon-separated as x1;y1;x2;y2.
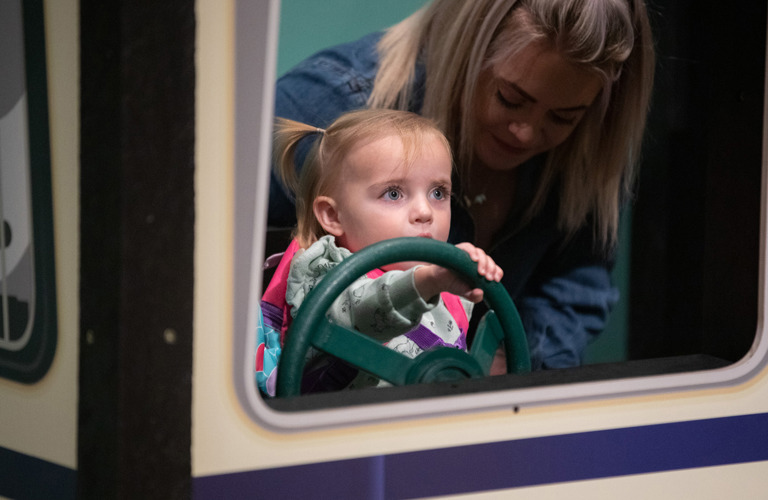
269;0;654;368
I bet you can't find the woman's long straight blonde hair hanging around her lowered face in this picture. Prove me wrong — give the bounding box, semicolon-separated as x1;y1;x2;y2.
368;0;655;247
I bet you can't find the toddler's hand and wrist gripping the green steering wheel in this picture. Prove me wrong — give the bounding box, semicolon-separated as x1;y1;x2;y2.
414;243;504;303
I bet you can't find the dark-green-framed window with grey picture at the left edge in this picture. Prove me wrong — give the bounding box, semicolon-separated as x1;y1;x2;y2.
0;0;57;383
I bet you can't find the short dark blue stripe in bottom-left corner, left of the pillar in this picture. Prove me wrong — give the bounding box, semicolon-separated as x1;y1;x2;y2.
0;447;77;500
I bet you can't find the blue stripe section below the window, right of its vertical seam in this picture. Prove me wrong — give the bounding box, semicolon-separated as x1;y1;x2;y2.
386;414;768;498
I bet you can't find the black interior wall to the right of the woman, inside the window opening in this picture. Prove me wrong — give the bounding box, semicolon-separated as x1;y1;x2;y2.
628;0;766;361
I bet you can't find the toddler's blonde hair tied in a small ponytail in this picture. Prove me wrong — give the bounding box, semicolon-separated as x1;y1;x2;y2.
273;109;451;248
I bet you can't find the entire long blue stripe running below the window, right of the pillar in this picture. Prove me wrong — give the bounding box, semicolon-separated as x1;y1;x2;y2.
192;413;768;499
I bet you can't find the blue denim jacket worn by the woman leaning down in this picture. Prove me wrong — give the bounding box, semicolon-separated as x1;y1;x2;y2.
268;33;618;369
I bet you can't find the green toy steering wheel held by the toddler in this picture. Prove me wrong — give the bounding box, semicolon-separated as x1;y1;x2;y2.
277;238;531;397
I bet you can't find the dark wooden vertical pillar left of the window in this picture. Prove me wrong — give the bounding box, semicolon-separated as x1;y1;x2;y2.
78;0;195;498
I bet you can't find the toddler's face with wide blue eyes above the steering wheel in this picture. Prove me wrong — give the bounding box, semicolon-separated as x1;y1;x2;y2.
333;134;451;268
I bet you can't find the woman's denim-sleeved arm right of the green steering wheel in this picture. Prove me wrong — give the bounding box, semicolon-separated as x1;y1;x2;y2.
491;200;618;370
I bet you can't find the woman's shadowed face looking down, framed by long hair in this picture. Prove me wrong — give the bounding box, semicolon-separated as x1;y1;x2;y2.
474;44;602;170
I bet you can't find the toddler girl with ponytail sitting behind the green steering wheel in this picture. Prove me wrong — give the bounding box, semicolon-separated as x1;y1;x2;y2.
257;110;502;395
